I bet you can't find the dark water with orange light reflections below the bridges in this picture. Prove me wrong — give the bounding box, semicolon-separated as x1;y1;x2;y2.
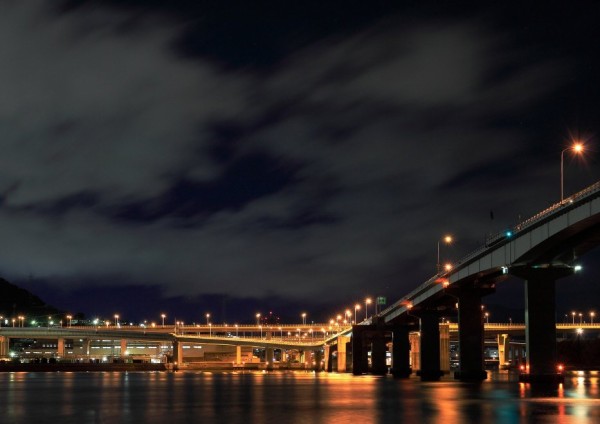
0;372;600;424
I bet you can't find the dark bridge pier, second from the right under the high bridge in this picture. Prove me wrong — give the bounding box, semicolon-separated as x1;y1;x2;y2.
454;288;487;381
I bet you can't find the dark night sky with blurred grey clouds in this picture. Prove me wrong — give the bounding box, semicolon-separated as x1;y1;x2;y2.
0;0;600;321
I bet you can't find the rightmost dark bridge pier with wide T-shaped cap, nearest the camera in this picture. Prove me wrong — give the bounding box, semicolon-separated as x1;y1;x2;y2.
510;267;573;383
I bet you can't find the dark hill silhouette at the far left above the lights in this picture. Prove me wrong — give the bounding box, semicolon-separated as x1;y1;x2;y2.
0;278;64;322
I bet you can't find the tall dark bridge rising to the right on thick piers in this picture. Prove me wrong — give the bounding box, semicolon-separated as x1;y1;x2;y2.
352;182;600;381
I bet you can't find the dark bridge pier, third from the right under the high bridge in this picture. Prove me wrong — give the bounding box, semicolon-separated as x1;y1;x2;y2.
419;311;443;381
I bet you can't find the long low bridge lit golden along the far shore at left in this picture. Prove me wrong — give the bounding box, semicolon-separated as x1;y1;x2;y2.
0;324;350;367
